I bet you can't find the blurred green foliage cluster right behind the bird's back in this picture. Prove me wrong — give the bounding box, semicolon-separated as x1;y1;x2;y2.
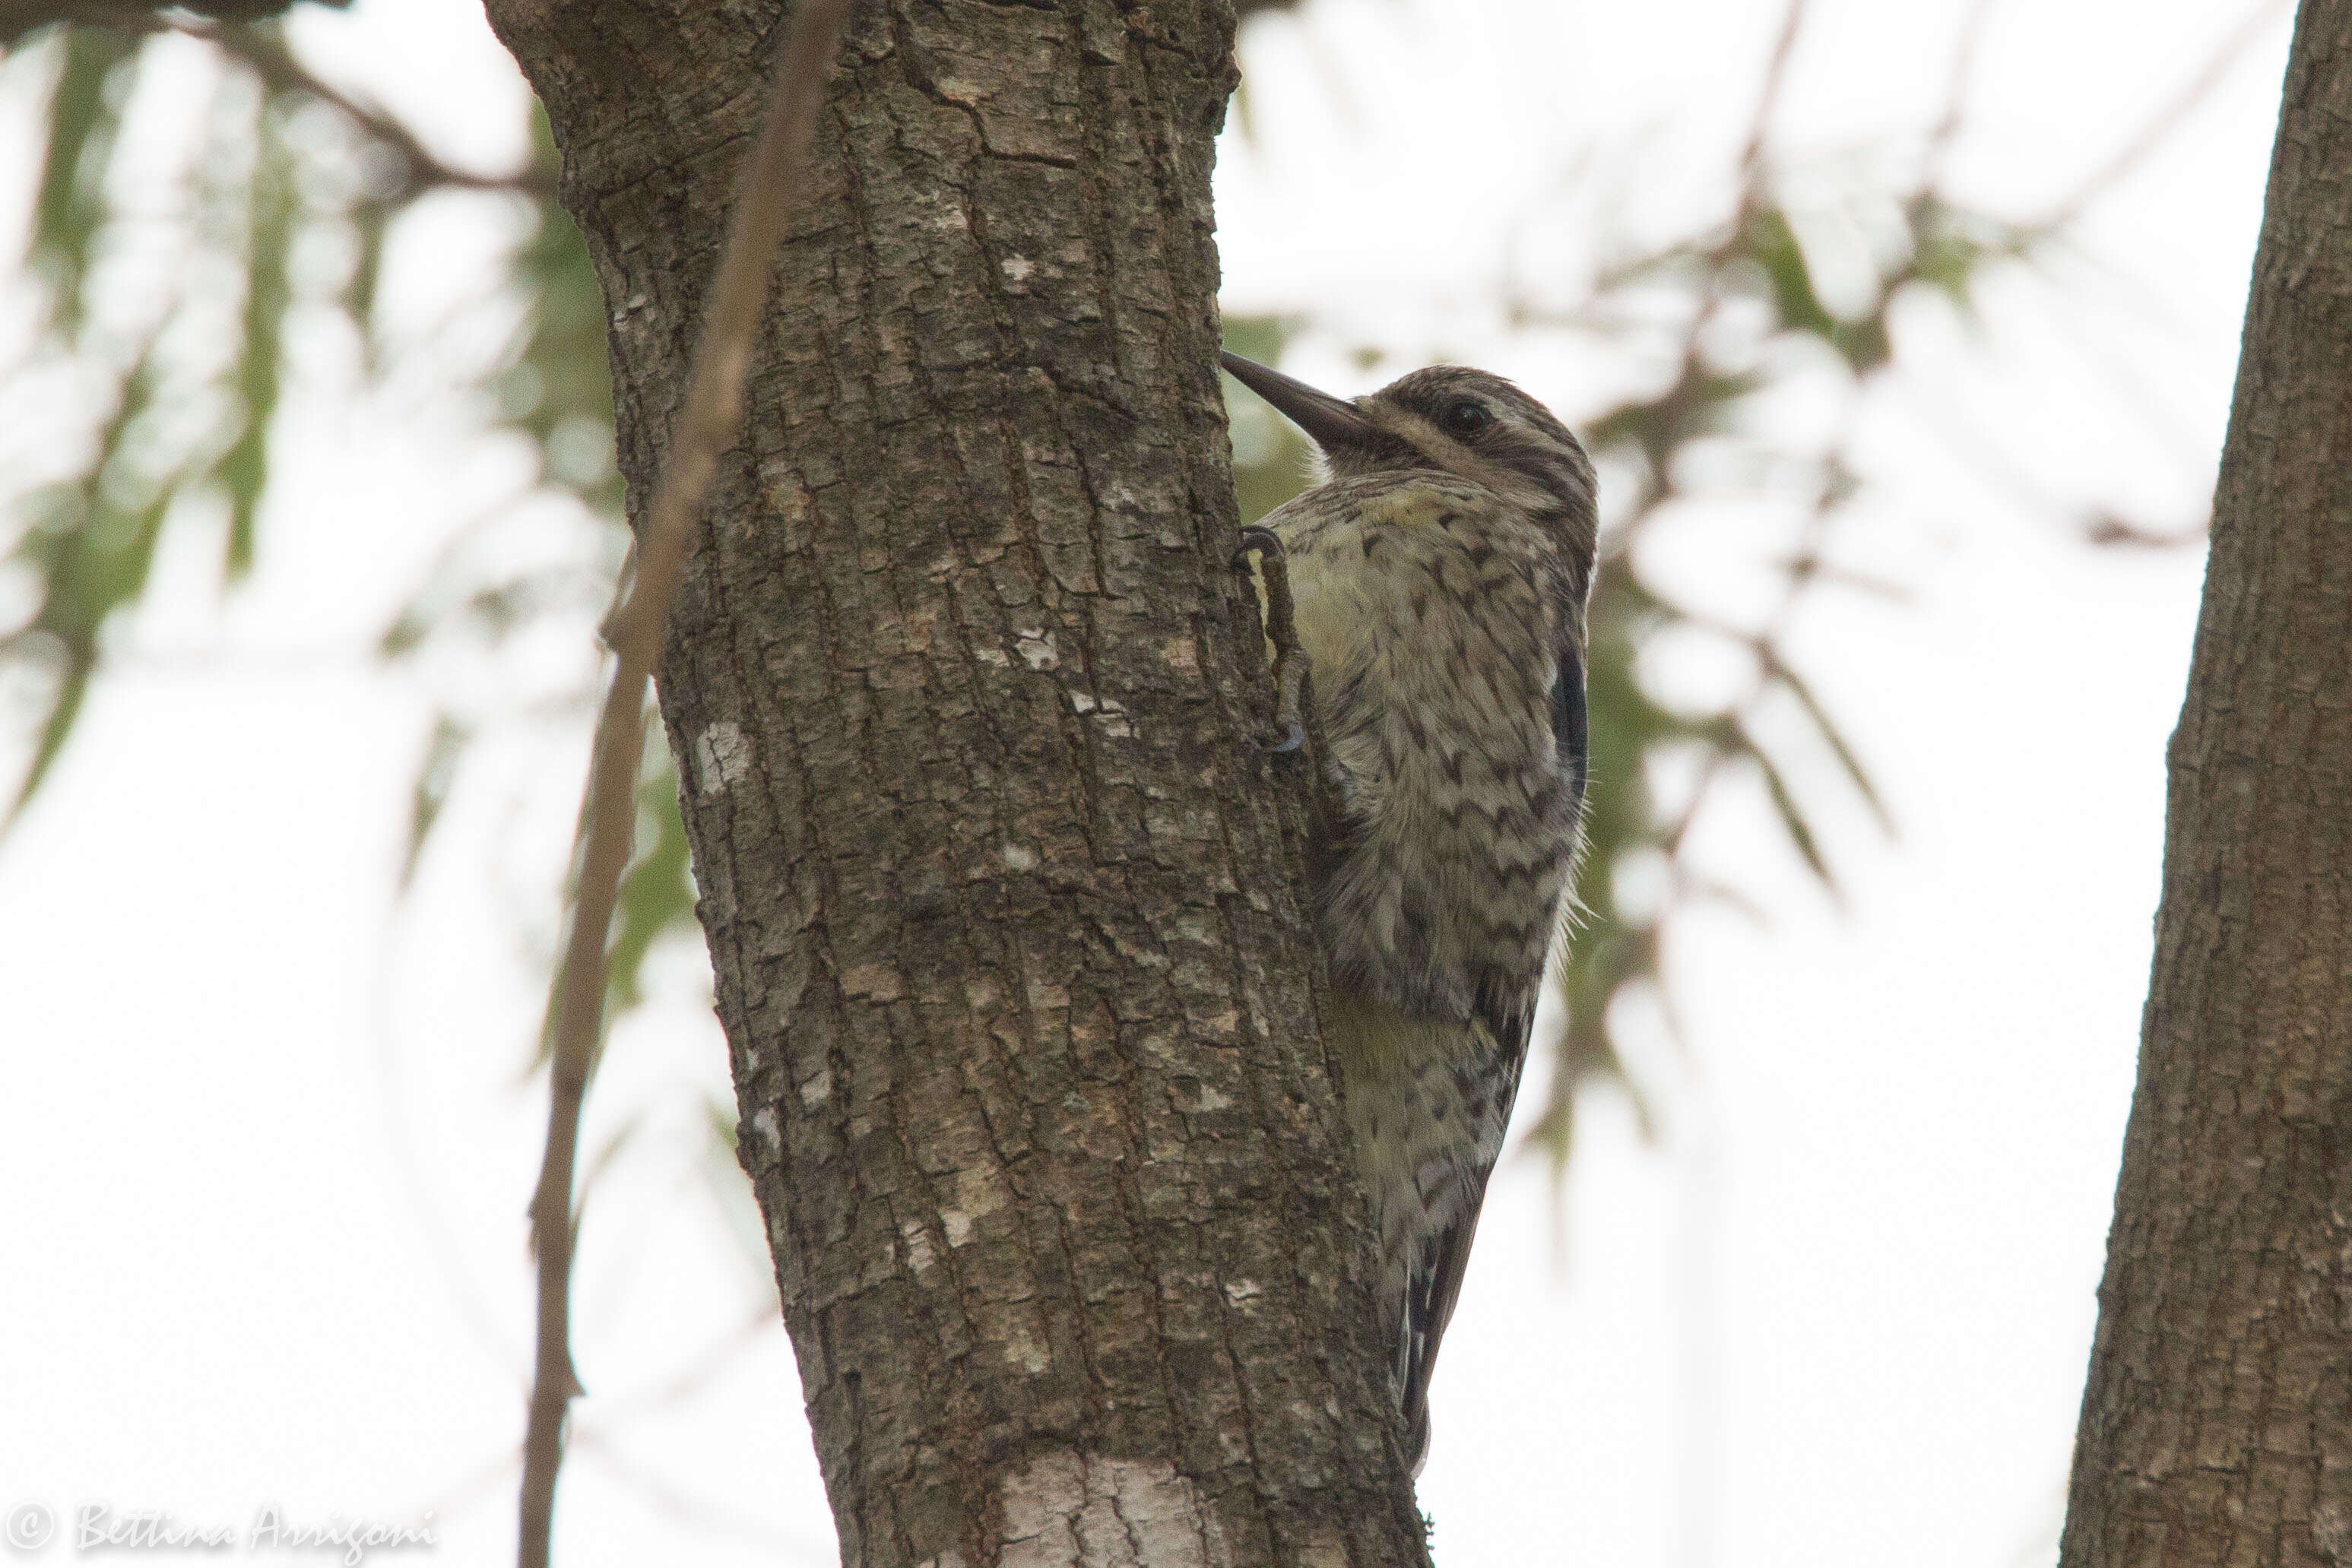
1517;169;2049;1159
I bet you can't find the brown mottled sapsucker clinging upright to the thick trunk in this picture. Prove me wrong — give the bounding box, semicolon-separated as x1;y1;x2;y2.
1225;355;1597;1474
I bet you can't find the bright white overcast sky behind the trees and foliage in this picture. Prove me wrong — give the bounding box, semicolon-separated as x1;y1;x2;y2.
0;0;2286;1568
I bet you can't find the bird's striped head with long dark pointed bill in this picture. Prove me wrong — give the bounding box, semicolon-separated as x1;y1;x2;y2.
1225;355;1599;559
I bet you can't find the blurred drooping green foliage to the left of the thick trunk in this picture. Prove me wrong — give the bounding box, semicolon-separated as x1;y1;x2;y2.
0;18;694;1044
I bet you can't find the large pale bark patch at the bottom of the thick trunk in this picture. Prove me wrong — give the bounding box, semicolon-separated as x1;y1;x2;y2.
1000;1452;1232;1568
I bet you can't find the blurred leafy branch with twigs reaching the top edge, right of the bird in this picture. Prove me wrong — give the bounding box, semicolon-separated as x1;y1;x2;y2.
1477;0;2230;1161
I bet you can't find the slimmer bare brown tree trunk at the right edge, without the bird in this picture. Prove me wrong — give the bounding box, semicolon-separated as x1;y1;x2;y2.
2062;0;2352;1568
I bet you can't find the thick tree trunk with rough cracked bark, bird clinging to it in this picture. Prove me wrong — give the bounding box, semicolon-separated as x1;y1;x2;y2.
490;0;1425;1568
